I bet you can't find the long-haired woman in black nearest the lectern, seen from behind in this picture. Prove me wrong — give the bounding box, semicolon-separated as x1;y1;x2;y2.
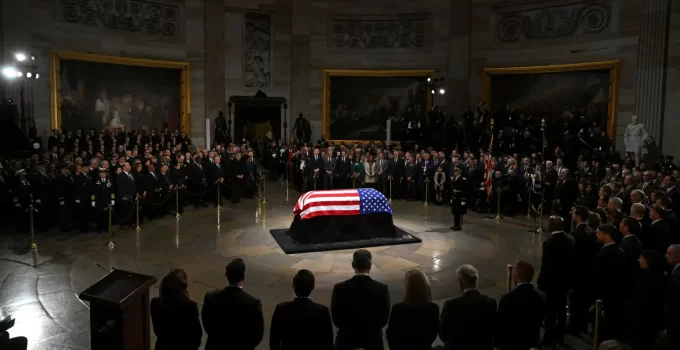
151;269;203;350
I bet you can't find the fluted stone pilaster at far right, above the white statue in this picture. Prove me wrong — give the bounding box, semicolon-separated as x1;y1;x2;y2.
635;0;670;147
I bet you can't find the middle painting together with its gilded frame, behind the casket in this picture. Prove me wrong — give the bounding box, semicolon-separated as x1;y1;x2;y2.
322;69;434;142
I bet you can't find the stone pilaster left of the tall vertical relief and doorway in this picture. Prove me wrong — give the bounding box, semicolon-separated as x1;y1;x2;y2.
205;0;227;141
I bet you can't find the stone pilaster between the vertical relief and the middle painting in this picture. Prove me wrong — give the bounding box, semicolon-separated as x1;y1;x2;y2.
288;0;310;139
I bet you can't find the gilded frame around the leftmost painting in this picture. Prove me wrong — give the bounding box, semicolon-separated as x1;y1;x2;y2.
50;50;191;135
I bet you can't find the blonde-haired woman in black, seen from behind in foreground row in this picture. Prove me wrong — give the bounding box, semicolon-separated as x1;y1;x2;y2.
386;269;439;350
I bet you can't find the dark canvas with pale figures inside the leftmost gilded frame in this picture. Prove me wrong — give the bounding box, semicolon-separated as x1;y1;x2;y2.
59;60;181;131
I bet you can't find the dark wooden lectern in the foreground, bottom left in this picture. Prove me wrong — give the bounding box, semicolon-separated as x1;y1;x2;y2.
80;270;157;350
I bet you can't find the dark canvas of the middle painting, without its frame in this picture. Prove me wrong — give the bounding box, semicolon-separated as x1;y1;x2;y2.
326;76;429;140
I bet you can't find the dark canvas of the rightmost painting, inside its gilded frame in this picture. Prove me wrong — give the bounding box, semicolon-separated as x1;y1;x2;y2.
490;69;610;130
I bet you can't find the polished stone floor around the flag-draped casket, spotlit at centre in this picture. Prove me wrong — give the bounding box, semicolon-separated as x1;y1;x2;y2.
0;184;589;350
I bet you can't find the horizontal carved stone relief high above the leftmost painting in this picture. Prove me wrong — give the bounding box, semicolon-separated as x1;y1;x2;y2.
59;0;179;37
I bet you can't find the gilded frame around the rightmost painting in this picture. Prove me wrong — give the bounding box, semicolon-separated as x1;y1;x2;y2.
482;60;621;140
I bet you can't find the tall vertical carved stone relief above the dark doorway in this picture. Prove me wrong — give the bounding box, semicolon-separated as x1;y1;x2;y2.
243;12;272;88
